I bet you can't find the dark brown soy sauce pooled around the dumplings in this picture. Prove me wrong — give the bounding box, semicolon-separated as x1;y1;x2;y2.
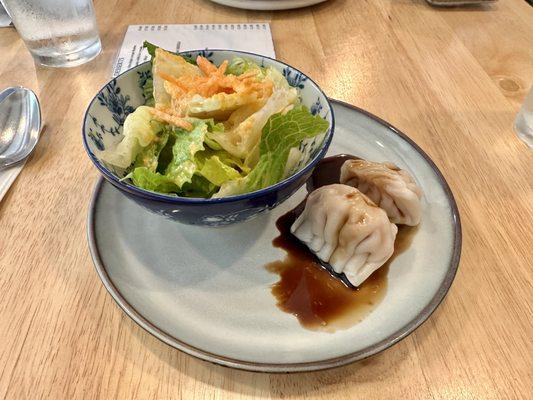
266;155;417;332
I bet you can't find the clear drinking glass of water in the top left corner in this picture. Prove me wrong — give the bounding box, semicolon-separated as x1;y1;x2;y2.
1;0;102;67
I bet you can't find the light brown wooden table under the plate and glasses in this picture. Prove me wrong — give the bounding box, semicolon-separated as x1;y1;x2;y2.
0;0;533;399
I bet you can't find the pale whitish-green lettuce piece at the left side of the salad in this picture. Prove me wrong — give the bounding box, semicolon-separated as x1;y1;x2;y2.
102;106;163;168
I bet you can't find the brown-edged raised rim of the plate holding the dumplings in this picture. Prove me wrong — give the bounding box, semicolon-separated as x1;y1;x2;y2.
87;99;462;373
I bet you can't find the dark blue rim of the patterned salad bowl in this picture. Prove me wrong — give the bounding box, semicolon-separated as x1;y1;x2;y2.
81;48;335;205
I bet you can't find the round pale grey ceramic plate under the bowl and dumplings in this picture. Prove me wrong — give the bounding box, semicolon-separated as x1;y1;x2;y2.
88;102;461;372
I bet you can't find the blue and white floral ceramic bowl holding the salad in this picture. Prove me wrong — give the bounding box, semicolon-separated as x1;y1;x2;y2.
82;50;335;226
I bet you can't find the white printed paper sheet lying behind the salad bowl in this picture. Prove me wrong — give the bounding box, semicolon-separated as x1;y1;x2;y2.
113;22;276;76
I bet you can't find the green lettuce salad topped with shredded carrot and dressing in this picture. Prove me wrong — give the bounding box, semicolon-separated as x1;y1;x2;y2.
98;42;329;198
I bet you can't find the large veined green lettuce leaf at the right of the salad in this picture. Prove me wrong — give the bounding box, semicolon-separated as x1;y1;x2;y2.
214;105;329;197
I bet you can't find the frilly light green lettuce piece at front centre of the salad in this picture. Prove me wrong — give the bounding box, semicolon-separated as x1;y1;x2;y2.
165;120;207;188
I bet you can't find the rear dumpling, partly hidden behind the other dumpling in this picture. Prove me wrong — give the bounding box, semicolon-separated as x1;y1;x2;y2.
340;159;422;226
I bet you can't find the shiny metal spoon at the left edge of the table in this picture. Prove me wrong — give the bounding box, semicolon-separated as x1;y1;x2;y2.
0;87;41;169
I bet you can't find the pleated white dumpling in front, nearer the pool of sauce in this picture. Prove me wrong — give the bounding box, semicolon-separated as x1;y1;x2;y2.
291;184;398;286
